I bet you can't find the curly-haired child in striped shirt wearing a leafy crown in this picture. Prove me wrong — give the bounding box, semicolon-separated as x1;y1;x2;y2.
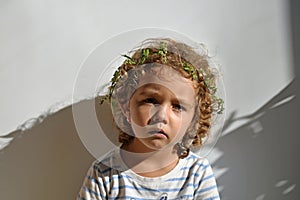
78;38;223;200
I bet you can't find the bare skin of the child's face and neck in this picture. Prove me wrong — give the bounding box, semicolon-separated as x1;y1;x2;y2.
123;67;195;177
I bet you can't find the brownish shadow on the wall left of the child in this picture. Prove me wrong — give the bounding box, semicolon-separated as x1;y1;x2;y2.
0;96;117;200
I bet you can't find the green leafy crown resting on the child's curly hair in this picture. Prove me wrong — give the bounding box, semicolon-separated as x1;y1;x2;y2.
100;41;224;114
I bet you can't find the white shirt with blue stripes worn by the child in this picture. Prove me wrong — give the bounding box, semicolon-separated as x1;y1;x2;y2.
77;148;220;200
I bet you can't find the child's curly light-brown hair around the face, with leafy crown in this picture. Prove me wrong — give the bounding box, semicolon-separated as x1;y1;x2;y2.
104;38;223;158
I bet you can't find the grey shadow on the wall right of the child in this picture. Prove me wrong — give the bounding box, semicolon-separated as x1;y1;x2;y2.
214;81;300;200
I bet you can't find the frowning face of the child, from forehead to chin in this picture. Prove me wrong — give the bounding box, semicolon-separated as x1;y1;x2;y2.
129;66;196;152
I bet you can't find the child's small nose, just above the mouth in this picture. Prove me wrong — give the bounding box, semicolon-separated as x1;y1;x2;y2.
148;105;167;124
